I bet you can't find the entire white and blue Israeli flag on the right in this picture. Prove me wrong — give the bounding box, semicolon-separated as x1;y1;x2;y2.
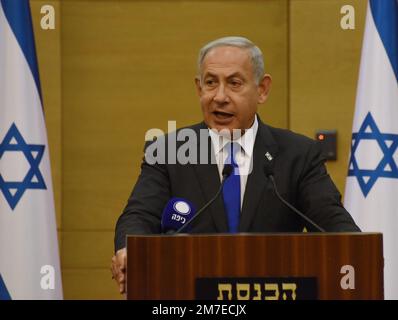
345;0;398;299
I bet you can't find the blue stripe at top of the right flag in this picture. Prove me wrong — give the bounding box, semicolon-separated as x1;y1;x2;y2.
369;0;398;81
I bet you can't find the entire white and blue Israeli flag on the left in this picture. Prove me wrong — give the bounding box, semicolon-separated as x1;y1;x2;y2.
0;0;62;299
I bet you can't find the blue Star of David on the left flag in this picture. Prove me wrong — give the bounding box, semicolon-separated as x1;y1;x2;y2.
0;123;46;209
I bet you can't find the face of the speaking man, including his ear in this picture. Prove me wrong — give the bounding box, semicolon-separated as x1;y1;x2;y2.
196;46;271;131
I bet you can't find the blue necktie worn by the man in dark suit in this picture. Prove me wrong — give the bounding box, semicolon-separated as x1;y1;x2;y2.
223;142;241;233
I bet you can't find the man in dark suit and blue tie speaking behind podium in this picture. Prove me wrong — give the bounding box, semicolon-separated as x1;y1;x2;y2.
112;37;360;292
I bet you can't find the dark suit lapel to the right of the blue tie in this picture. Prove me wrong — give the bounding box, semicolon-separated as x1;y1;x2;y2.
239;118;278;232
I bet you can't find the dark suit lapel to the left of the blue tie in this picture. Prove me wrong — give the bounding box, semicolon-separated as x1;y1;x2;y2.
193;123;228;232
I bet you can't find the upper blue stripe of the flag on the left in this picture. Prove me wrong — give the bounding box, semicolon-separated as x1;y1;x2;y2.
0;0;43;105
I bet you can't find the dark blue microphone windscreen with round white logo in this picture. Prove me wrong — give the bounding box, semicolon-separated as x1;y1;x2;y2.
161;197;196;233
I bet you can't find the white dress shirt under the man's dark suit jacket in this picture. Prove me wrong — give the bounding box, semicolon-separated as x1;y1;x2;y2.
209;115;258;209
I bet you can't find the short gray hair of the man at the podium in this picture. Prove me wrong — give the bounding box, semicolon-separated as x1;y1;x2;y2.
198;37;264;84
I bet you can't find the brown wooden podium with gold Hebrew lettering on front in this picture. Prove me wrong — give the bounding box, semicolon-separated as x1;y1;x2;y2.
127;233;384;300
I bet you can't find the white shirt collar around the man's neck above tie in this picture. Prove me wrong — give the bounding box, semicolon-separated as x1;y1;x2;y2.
209;115;258;157
